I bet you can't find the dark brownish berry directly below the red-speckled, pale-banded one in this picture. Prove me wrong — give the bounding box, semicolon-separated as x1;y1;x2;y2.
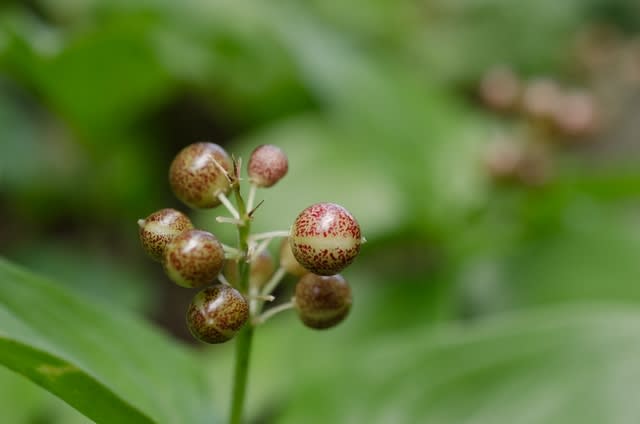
294;274;352;330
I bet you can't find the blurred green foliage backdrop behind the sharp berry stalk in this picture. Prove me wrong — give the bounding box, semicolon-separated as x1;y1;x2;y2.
0;0;640;424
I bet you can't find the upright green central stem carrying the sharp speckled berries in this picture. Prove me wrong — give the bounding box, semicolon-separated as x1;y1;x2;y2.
229;186;254;424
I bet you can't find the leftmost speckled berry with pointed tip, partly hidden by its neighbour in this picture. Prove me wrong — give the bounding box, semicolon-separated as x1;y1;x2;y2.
138;208;193;262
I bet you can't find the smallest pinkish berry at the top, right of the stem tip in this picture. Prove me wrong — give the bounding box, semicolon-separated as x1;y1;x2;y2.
247;144;289;187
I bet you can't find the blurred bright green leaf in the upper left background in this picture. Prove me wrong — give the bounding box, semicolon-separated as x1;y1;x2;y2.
4;16;170;136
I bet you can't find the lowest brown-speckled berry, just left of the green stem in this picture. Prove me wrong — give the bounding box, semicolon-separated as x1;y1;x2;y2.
187;284;249;344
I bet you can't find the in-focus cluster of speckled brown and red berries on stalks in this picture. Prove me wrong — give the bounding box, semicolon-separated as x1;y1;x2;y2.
138;142;364;343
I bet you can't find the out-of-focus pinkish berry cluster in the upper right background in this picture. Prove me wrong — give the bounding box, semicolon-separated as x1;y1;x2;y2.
478;66;605;187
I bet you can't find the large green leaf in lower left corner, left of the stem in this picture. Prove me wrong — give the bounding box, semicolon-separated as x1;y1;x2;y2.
0;259;215;423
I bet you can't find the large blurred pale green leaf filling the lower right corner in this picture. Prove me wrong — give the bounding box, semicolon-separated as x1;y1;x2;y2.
276;306;640;424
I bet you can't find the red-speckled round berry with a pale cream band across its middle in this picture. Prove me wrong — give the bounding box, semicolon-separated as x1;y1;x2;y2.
289;203;362;275
